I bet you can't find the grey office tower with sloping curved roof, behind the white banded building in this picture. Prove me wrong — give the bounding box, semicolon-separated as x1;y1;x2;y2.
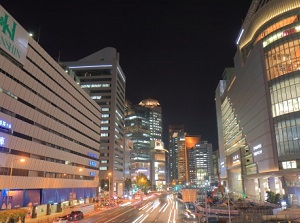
62;47;126;196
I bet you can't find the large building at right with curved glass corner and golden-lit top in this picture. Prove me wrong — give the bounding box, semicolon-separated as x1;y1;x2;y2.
216;0;300;205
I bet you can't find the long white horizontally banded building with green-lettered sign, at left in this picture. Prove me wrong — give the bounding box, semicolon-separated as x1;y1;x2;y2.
0;6;101;216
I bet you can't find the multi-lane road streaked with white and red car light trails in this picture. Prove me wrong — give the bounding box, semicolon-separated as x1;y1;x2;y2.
77;194;198;223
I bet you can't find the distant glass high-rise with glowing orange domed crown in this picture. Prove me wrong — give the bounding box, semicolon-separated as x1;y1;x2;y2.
125;99;162;180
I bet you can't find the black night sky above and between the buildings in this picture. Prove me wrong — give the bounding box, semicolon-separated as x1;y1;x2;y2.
0;0;251;149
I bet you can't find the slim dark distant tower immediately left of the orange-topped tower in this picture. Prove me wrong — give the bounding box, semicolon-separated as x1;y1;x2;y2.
167;125;185;184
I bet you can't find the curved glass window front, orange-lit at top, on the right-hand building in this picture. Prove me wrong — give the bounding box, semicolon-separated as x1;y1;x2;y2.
265;34;300;160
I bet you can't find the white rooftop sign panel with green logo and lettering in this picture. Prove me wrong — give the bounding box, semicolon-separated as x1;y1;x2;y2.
0;5;29;64
